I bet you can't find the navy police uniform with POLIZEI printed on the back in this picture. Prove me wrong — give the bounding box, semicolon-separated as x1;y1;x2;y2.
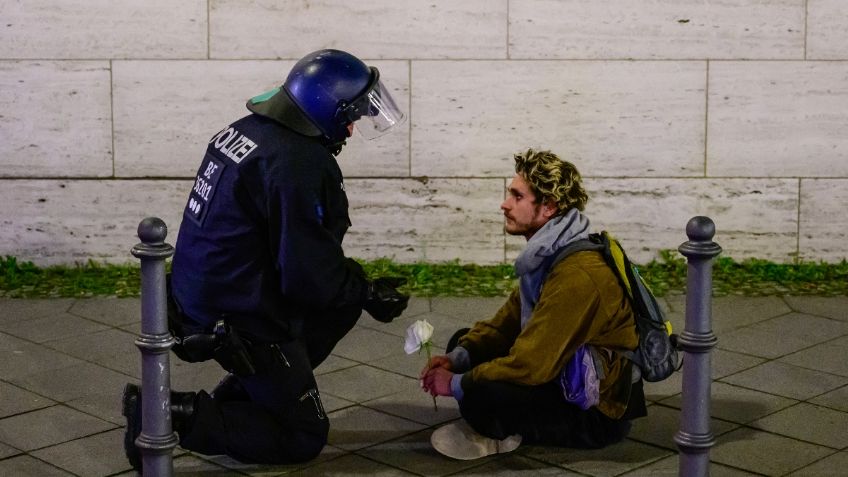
171;114;366;462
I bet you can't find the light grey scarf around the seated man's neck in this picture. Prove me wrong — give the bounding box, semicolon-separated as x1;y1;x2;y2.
515;209;589;329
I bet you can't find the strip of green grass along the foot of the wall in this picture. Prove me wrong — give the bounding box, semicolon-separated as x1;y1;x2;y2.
0;250;848;298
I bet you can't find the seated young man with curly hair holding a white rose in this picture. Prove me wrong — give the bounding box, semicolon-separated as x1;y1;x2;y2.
421;149;646;459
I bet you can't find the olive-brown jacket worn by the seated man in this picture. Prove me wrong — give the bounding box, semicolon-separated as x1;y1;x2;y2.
458;251;638;419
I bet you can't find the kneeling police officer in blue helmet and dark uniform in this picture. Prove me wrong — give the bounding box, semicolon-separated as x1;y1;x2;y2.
123;50;409;469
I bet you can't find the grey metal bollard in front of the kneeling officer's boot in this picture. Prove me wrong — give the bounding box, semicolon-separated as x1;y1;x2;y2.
132;217;178;477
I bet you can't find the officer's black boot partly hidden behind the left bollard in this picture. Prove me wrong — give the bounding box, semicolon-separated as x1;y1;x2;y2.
121;383;197;472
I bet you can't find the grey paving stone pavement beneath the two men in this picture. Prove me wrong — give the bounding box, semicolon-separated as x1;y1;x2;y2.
0;296;848;477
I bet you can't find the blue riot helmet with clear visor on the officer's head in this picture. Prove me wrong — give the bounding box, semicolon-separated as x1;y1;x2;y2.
247;50;405;144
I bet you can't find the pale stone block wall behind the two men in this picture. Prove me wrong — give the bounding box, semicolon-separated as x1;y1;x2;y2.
0;0;848;265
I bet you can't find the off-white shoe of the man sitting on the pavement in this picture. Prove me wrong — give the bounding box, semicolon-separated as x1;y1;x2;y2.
430;419;521;460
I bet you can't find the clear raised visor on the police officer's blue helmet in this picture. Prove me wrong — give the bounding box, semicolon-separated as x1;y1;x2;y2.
344;80;406;139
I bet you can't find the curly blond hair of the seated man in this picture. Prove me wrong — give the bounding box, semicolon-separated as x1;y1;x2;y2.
514;149;589;215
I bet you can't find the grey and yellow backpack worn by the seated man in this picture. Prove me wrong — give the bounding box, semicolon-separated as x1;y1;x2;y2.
548;231;678;382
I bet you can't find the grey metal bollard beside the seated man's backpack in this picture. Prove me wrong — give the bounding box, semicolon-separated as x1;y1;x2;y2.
674;217;721;477
